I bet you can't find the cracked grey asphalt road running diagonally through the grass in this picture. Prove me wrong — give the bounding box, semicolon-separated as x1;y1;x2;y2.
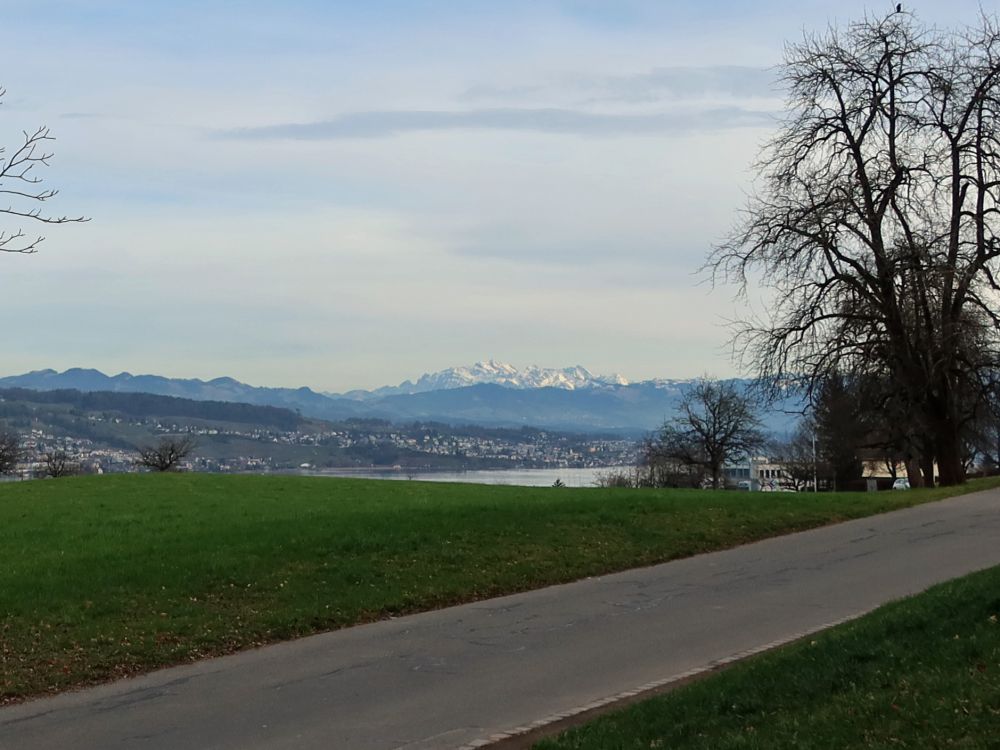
0;491;1000;750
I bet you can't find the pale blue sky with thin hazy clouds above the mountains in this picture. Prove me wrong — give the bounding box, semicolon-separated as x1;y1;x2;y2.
0;0;993;392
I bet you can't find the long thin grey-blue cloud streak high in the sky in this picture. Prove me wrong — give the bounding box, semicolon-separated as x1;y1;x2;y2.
223;107;774;141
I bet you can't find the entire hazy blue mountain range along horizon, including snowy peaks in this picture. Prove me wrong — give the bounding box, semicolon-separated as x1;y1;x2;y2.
0;360;795;435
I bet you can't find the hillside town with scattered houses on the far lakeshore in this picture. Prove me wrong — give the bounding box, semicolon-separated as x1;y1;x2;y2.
0;392;639;478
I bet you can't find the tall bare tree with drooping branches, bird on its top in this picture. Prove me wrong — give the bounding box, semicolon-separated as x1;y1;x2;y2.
708;12;1000;484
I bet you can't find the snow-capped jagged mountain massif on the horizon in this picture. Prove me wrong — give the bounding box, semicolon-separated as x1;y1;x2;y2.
354;359;629;398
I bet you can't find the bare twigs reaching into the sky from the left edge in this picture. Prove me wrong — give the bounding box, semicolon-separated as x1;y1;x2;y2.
0;88;88;253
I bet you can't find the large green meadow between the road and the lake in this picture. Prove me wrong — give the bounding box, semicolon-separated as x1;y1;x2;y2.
0;474;986;702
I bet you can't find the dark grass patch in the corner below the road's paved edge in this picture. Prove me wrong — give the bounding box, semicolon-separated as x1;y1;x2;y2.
534;568;1000;750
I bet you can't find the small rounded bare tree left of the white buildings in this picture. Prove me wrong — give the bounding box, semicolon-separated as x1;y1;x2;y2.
656;378;764;488
